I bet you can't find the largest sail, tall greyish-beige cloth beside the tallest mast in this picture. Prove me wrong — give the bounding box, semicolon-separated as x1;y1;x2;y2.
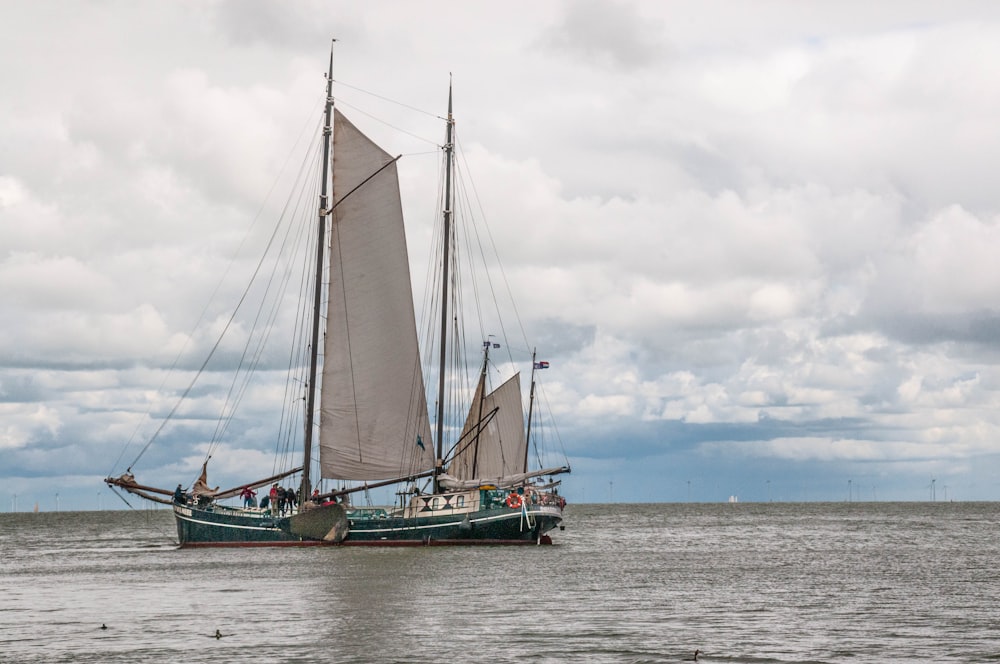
320;109;434;480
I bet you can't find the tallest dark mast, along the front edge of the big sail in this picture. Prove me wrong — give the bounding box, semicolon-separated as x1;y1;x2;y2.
299;39;337;503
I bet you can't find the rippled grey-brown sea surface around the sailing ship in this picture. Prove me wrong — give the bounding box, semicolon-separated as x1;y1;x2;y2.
0;503;1000;662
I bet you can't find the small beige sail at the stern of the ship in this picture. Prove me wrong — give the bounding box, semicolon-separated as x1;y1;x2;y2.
448;374;527;480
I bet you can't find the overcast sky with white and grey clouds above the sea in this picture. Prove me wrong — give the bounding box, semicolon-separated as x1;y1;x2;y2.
0;0;1000;511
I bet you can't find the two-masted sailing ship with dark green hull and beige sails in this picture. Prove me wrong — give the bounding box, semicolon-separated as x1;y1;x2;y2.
105;45;570;547
